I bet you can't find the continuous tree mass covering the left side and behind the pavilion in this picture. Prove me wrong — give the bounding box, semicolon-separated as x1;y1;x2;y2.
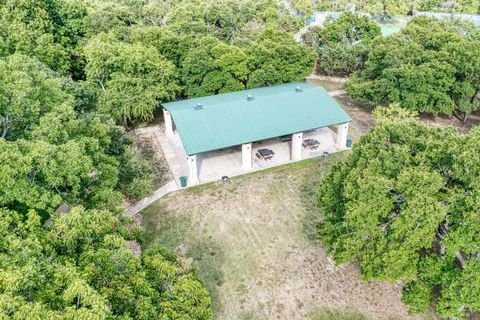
0;0;314;319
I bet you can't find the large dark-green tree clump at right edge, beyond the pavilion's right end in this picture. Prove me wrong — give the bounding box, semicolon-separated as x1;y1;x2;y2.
347;17;480;120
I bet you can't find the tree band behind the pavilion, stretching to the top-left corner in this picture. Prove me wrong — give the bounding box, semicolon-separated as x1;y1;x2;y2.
0;0;314;125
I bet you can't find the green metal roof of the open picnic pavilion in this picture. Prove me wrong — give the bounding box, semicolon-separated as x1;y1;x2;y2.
163;82;352;155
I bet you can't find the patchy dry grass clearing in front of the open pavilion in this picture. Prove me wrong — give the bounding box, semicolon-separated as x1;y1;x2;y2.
142;154;416;320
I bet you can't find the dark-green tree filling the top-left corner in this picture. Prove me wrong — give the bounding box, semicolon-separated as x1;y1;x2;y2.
0;0;86;75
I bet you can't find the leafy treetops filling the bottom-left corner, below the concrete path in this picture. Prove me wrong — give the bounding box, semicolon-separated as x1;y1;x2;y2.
0;207;212;319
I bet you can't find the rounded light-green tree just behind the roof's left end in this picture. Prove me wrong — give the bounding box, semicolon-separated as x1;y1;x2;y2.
85;34;179;127
